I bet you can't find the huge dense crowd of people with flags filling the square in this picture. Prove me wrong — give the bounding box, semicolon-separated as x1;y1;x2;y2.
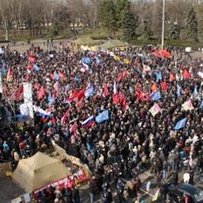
0;43;203;203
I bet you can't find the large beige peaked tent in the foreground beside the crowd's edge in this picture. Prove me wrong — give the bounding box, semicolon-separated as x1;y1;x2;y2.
12;152;71;192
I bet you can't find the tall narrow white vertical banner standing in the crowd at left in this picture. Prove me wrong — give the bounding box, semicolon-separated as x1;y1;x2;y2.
23;82;34;119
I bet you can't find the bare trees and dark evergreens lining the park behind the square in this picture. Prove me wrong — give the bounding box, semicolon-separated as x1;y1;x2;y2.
0;0;203;41
